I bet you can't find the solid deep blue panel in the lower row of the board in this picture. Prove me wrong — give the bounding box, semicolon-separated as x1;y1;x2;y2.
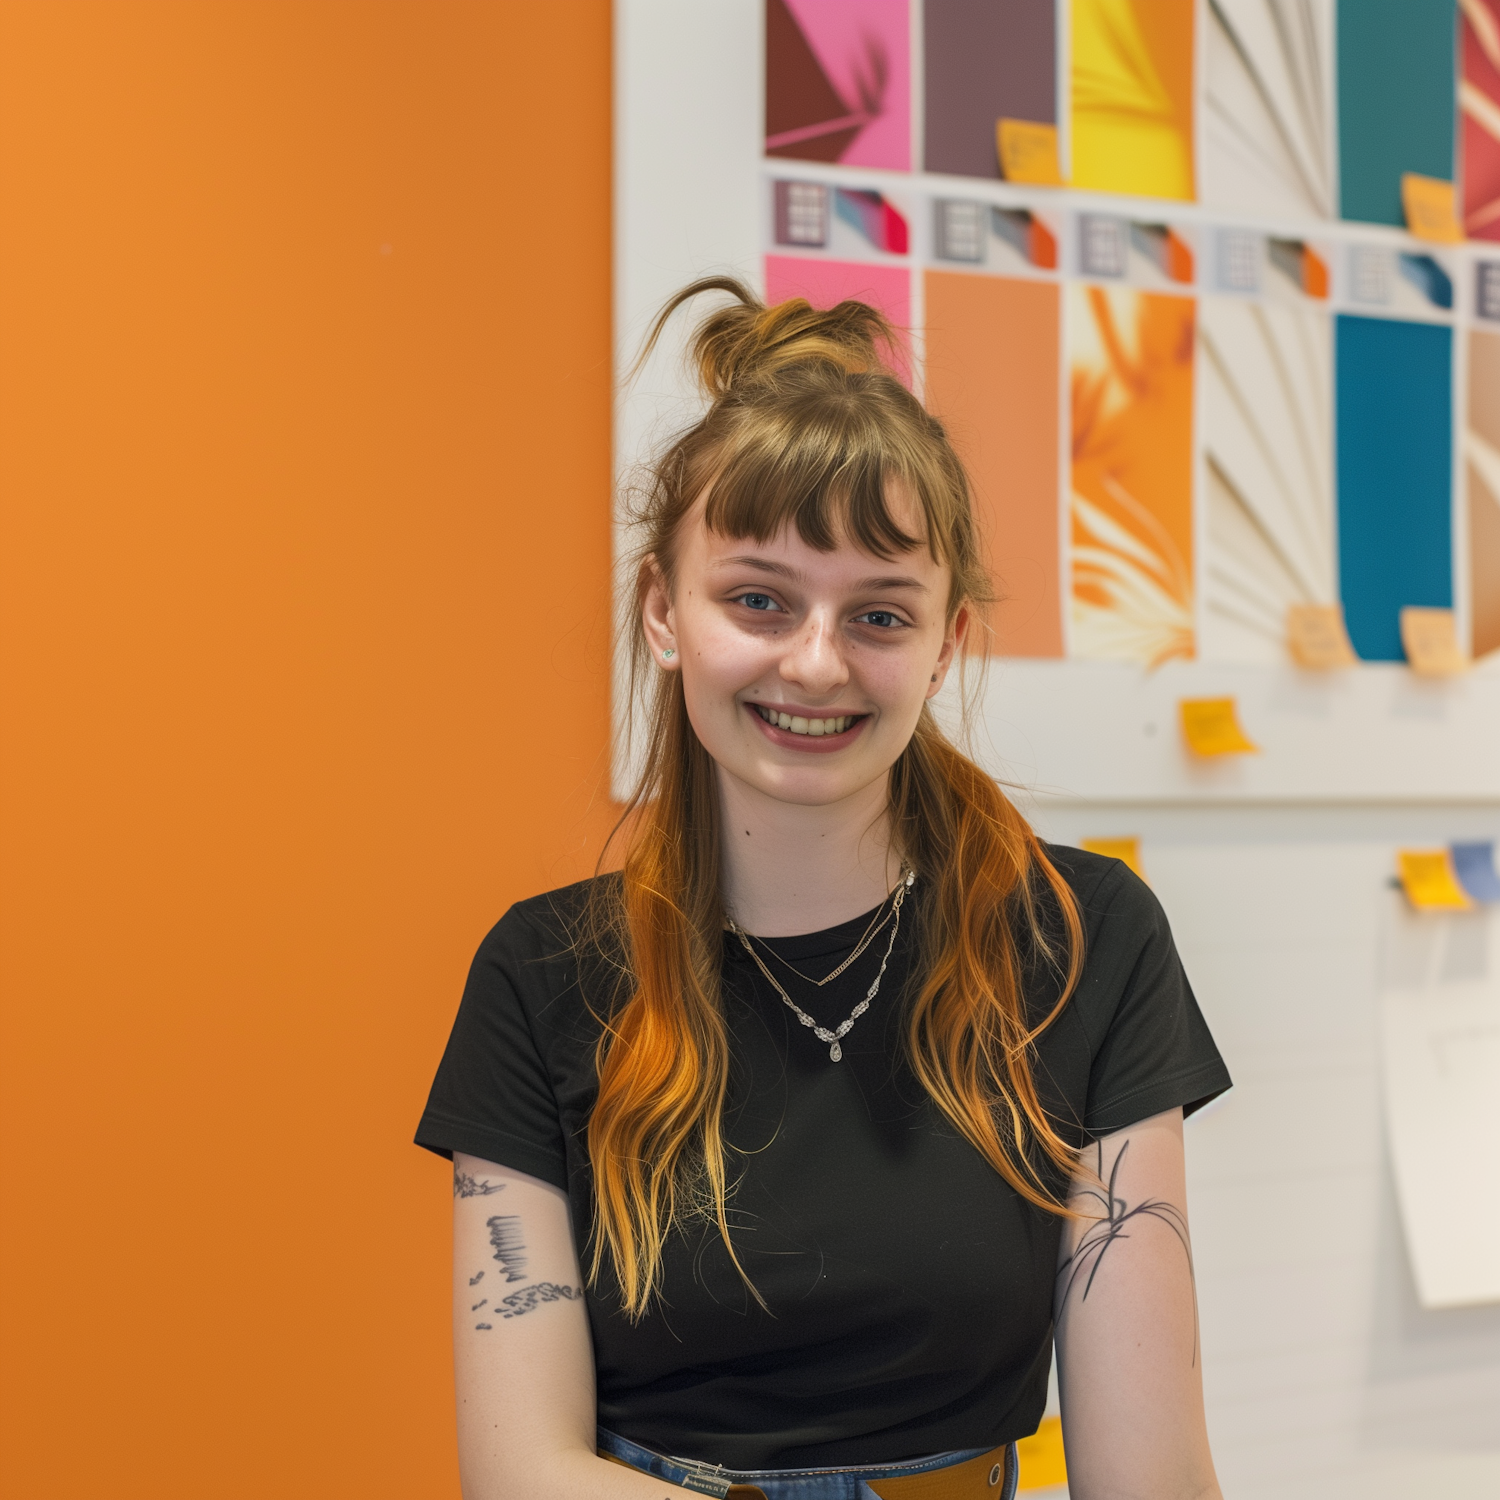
1334;314;1454;662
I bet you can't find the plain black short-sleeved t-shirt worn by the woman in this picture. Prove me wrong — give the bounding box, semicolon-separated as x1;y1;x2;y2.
417;848;1230;1469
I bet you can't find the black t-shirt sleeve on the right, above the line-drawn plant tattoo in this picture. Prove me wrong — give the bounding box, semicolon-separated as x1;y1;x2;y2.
1079;864;1232;1136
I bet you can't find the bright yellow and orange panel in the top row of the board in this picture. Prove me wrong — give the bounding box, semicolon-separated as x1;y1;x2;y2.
1071;0;1196;198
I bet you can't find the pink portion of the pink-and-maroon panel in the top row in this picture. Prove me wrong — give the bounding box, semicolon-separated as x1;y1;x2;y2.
786;0;912;173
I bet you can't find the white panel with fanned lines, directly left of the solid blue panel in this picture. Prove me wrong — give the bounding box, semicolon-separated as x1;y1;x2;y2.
1199;297;1338;665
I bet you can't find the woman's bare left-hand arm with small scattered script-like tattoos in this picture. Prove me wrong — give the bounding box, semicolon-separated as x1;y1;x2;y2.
453;1155;687;1500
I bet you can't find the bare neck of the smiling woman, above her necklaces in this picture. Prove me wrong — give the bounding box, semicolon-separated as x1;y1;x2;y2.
719;770;902;938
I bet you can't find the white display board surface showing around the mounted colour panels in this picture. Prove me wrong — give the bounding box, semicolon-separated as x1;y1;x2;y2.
615;0;1500;803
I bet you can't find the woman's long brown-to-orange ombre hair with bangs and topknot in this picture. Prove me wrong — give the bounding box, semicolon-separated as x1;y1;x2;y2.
579;278;1083;1317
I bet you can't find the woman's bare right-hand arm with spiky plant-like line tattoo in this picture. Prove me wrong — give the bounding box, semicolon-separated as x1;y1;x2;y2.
1055;1110;1221;1500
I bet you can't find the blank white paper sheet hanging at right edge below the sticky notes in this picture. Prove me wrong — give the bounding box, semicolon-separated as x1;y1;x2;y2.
1382;893;1500;1308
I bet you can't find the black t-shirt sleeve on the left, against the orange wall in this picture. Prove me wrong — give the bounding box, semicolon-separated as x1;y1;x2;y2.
417;908;567;1190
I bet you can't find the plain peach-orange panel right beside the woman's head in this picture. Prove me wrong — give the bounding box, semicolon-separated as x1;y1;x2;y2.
924;272;1062;657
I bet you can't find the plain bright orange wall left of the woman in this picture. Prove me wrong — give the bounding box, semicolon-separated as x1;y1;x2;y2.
0;0;609;1500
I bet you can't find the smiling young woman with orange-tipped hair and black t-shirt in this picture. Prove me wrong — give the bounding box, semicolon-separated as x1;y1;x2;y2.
417;279;1229;1500
